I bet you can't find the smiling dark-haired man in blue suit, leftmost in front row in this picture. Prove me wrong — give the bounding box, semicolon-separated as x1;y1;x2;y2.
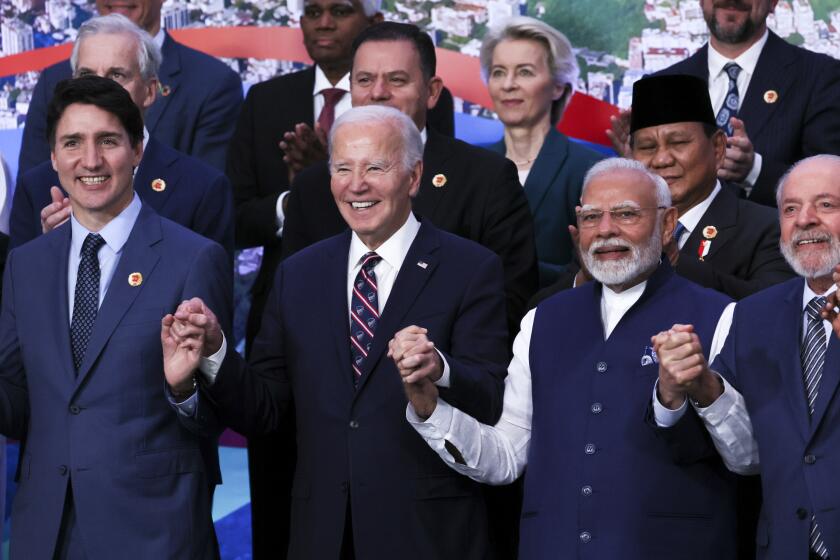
0;76;232;560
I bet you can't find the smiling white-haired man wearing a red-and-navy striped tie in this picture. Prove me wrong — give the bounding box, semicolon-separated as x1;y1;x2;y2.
164;106;507;560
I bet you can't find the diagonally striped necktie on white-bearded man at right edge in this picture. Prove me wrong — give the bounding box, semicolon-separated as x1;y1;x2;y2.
801;297;828;558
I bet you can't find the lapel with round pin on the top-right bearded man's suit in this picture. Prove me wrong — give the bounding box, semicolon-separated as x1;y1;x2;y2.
738;31;796;142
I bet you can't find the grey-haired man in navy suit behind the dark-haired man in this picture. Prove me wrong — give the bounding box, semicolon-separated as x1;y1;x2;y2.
10;14;233;254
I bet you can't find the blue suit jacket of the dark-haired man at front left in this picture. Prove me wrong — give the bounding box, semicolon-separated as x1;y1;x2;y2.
0;206;232;559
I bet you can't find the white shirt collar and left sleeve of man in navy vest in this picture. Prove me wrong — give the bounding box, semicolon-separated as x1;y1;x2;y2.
406;282;736;484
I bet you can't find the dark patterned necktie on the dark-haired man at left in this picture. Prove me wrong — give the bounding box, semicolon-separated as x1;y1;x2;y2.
70;233;105;372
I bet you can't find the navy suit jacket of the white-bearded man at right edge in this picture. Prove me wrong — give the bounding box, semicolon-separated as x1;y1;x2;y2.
712;278;840;560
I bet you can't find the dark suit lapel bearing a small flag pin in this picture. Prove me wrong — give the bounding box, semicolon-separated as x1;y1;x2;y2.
354;223;440;395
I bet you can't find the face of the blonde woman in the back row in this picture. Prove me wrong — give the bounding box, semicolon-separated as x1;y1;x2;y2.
487;39;564;127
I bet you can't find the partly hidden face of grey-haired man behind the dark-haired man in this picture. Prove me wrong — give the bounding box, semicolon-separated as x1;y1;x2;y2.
73;33;158;112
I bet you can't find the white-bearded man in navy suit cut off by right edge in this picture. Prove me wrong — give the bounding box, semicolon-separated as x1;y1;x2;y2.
654;155;840;560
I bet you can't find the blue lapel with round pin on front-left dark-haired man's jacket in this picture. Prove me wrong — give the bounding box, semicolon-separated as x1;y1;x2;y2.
76;206;161;391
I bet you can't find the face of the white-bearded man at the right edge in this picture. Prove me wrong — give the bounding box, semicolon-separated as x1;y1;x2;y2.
779;160;840;286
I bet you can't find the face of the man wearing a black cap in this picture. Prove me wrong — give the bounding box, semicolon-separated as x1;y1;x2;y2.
632;122;726;215
